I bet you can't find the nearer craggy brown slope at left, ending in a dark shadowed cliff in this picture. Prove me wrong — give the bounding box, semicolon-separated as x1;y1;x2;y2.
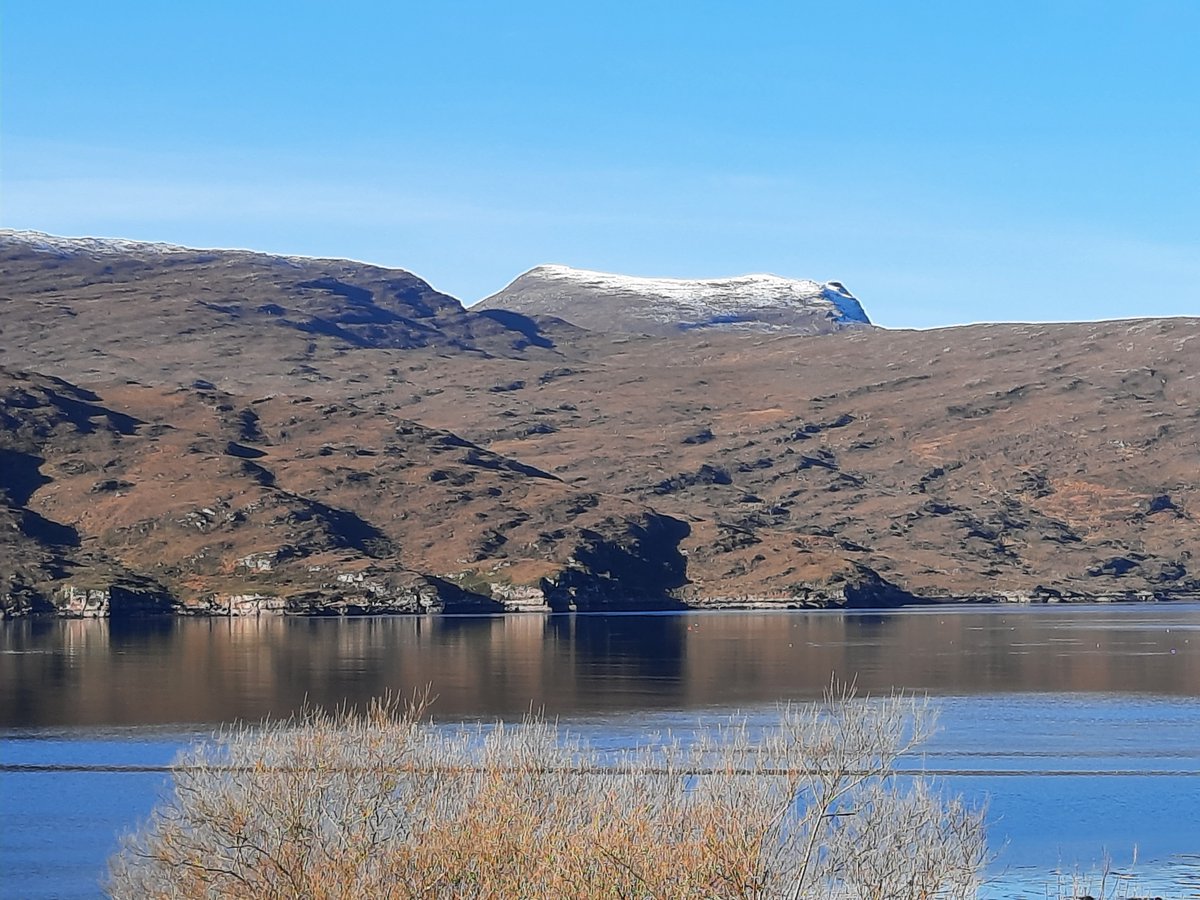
0;371;688;614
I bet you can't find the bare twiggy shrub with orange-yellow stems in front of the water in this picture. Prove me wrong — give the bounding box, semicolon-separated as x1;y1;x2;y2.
108;691;985;900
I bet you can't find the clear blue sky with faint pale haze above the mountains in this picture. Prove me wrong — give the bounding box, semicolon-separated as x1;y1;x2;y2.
0;0;1200;326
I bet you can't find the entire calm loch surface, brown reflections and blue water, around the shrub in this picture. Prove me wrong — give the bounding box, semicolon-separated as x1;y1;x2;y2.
0;605;1200;898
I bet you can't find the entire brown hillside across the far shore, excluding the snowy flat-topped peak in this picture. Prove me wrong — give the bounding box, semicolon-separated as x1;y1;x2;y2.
0;233;1200;616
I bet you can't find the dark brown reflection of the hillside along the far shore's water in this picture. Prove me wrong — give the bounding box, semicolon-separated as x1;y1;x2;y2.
0;606;1200;726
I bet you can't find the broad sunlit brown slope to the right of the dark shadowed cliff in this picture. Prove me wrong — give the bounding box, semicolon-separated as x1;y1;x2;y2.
400;319;1200;601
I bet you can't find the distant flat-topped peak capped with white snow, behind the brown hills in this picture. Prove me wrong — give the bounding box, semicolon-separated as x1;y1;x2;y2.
472;265;870;335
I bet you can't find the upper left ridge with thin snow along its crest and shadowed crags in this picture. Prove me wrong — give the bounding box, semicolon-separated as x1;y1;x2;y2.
0;230;561;382
